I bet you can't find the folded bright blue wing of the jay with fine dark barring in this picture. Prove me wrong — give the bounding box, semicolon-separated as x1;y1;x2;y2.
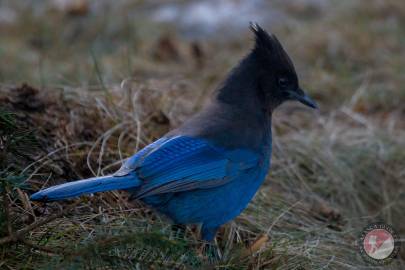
117;136;259;198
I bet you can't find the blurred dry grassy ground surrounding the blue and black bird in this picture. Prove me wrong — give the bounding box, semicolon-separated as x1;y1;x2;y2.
0;0;405;269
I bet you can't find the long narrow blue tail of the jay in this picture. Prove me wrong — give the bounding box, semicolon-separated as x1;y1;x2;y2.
31;174;141;202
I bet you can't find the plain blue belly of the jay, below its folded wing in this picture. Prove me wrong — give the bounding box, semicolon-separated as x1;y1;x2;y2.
158;165;267;225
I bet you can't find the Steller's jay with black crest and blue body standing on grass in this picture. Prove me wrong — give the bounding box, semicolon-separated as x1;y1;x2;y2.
31;24;317;241
